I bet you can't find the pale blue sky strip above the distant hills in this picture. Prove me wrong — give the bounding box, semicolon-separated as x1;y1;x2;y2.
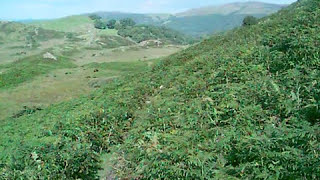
0;0;295;20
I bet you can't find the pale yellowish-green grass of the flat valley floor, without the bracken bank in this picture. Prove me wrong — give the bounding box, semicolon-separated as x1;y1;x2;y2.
0;44;185;120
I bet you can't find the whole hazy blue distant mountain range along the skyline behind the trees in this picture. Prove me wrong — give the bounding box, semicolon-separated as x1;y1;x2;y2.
20;2;287;37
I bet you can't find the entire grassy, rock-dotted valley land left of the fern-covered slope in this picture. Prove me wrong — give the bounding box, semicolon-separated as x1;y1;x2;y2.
0;16;184;121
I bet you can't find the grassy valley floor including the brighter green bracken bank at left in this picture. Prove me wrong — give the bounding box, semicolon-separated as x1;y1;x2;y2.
0;44;181;120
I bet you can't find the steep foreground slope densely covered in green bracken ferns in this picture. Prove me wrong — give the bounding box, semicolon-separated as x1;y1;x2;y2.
0;0;320;179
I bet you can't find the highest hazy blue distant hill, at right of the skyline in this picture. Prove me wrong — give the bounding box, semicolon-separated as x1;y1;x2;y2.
165;2;285;36
